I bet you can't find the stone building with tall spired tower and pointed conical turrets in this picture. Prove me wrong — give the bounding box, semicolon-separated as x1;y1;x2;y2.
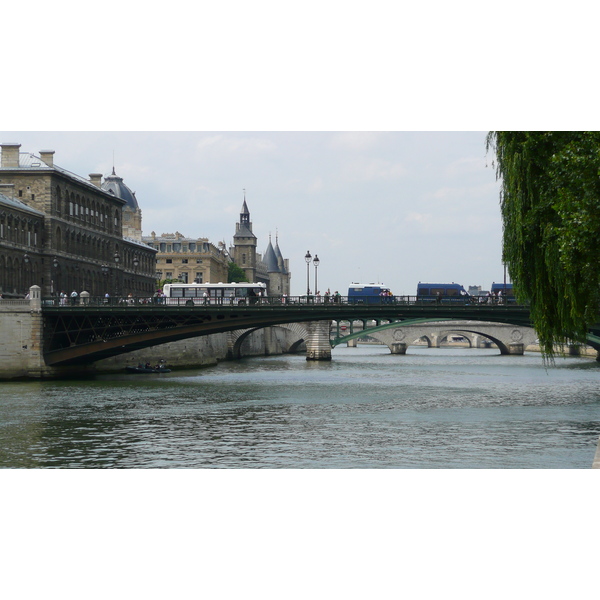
229;197;291;296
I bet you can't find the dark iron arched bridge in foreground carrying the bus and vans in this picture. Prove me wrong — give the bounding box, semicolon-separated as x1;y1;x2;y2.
42;296;600;366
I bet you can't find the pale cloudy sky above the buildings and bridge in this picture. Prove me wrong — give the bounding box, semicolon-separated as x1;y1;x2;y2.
1;131;504;295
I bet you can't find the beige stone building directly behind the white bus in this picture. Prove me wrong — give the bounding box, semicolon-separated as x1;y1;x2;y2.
142;231;229;283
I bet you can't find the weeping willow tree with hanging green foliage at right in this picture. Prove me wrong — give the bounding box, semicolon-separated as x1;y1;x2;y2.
487;131;600;358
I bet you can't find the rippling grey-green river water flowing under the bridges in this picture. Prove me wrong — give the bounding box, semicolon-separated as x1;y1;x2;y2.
0;345;600;469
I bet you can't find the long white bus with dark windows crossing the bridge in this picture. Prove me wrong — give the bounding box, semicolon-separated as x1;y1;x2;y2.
163;283;267;306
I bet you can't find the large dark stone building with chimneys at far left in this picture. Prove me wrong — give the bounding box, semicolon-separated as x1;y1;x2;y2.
0;143;156;296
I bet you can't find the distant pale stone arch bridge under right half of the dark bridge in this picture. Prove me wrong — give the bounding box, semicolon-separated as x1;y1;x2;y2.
369;321;537;355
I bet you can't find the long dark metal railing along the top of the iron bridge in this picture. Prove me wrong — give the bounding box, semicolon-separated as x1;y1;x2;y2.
42;294;515;308
